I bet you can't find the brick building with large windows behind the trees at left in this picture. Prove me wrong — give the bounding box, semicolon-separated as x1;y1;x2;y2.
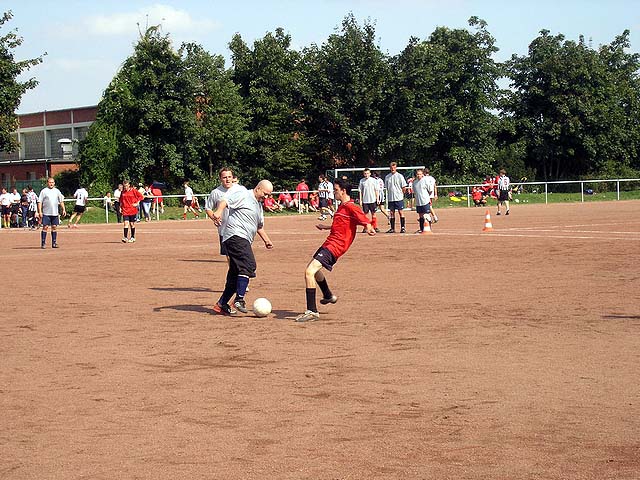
0;106;97;188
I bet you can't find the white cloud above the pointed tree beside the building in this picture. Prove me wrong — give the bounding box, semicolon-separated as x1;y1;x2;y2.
82;4;220;36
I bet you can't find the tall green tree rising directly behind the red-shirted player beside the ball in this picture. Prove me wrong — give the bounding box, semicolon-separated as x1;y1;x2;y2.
304;14;391;170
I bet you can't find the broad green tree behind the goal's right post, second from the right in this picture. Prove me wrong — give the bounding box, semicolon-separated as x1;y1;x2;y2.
385;17;502;180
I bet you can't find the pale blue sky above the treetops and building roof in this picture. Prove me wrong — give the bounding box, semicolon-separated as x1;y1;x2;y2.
6;0;640;113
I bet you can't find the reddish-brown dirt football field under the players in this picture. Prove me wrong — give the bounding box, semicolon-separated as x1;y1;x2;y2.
0;202;640;480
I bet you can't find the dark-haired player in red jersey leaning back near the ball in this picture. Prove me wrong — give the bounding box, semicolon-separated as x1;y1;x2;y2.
296;179;376;322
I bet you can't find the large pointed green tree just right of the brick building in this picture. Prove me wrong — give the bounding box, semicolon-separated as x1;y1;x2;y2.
80;27;200;191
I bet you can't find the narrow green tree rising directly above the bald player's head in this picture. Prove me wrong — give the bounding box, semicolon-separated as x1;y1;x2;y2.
229;28;310;187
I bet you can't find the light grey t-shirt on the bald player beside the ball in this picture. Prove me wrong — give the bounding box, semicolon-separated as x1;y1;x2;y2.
221;185;264;243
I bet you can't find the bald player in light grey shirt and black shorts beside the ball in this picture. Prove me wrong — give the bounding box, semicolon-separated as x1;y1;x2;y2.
212;180;273;315
